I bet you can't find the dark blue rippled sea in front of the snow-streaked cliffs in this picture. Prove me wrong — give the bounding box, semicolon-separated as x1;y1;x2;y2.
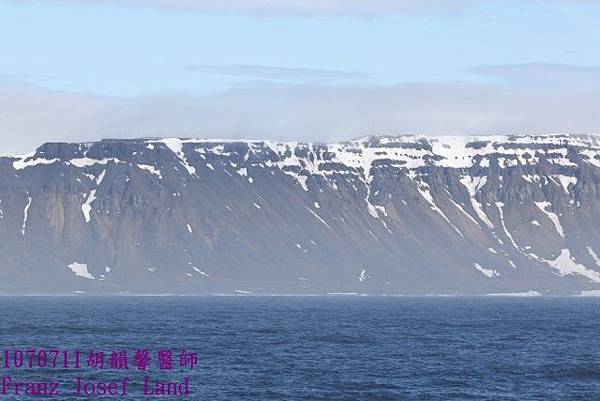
0;297;600;401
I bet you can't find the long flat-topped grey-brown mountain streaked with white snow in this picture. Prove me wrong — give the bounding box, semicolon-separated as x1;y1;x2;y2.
0;135;600;294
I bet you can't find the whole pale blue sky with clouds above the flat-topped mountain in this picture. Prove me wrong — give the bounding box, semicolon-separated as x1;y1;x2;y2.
0;0;600;154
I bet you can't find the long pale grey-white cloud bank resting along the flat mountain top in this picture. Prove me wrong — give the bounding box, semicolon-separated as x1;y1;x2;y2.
0;77;600;154
